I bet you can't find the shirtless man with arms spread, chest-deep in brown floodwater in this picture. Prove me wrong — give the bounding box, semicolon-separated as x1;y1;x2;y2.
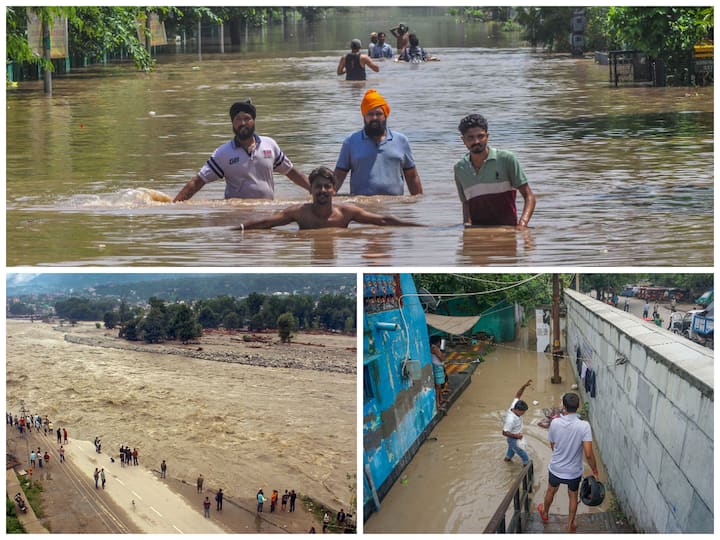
233;167;419;231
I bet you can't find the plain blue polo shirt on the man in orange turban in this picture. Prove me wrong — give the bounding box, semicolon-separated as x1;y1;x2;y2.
335;128;415;195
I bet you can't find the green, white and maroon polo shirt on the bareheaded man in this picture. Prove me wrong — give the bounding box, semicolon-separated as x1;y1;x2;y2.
455;148;528;225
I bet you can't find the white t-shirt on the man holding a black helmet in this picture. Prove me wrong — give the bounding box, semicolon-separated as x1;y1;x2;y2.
548;413;592;480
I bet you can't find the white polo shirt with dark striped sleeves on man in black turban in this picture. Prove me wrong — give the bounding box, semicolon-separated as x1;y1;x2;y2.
198;134;293;199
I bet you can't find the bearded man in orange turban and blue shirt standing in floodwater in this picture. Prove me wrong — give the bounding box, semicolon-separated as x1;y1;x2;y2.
335;88;423;195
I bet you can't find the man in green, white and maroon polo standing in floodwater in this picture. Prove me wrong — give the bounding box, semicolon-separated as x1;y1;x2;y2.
455;114;535;229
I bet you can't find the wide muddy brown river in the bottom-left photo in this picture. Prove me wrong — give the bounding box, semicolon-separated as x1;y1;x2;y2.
6;320;357;508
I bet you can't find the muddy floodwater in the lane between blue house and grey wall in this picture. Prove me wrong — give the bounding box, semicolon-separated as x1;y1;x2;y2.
364;319;610;533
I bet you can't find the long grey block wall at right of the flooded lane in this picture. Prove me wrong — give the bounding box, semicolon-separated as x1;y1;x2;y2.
565;290;714;533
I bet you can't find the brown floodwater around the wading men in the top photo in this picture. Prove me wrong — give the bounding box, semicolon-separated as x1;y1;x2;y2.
6;9;714;266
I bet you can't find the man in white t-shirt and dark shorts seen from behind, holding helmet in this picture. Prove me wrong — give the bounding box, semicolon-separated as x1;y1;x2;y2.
537;392;598;532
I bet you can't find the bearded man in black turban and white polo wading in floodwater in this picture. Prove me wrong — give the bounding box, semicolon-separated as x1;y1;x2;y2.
173;100;310;202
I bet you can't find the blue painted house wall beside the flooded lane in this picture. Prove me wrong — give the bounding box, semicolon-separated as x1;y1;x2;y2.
363;274;437;516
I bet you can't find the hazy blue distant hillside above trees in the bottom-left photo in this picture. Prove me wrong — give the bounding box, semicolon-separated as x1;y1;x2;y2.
6;274;357;301
